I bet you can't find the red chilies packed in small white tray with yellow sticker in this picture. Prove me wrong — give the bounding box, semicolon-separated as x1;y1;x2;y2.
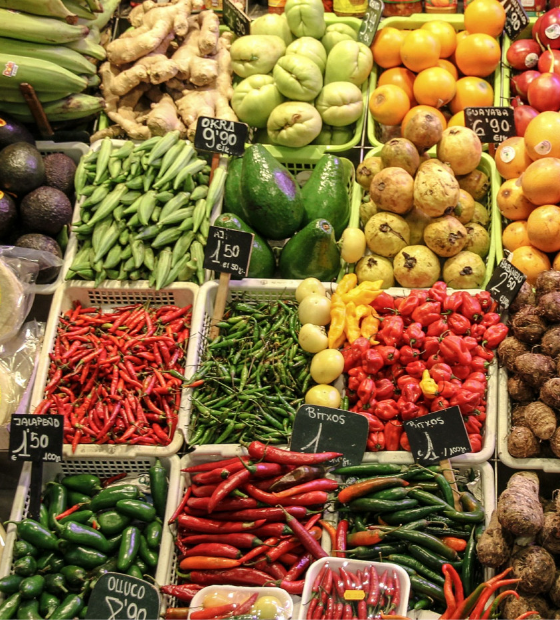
304;563;401;620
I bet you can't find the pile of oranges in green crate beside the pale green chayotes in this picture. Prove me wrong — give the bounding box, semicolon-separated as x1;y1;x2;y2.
369;0;506;129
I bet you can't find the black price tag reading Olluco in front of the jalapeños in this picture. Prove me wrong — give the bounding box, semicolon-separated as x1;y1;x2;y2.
86;573;160;620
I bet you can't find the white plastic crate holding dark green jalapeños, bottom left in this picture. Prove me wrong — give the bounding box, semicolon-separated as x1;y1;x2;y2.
0;456;181;596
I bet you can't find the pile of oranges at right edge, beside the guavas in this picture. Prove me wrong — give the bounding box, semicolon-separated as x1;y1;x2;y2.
495;112;560;282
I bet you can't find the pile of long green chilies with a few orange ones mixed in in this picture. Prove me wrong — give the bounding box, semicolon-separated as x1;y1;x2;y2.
335;463;484;611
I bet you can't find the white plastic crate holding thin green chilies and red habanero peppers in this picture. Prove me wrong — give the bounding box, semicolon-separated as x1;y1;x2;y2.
187;279;494;464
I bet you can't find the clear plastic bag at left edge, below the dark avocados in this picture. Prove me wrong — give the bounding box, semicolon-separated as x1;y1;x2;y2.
0;246;63;344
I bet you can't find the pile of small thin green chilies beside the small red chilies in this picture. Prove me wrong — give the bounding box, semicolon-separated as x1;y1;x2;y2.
189;299;312;445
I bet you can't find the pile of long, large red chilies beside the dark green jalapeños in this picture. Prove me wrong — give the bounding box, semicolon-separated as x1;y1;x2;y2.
161;441;341;602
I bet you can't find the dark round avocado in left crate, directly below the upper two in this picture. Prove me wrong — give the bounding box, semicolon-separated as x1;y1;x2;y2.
20;186;72;235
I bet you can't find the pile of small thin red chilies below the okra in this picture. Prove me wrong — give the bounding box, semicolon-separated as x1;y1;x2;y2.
34;303;191;451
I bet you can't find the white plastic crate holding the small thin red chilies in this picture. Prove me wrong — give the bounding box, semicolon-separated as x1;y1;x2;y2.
30;282;198;459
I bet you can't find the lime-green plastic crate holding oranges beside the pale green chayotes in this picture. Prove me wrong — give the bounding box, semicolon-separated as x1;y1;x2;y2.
367;13;502;146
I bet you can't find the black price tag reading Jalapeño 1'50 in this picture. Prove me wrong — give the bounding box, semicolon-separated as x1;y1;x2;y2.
10;414;64;463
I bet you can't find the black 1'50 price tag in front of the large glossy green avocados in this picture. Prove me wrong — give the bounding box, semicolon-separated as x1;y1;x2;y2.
204;226;255;278
